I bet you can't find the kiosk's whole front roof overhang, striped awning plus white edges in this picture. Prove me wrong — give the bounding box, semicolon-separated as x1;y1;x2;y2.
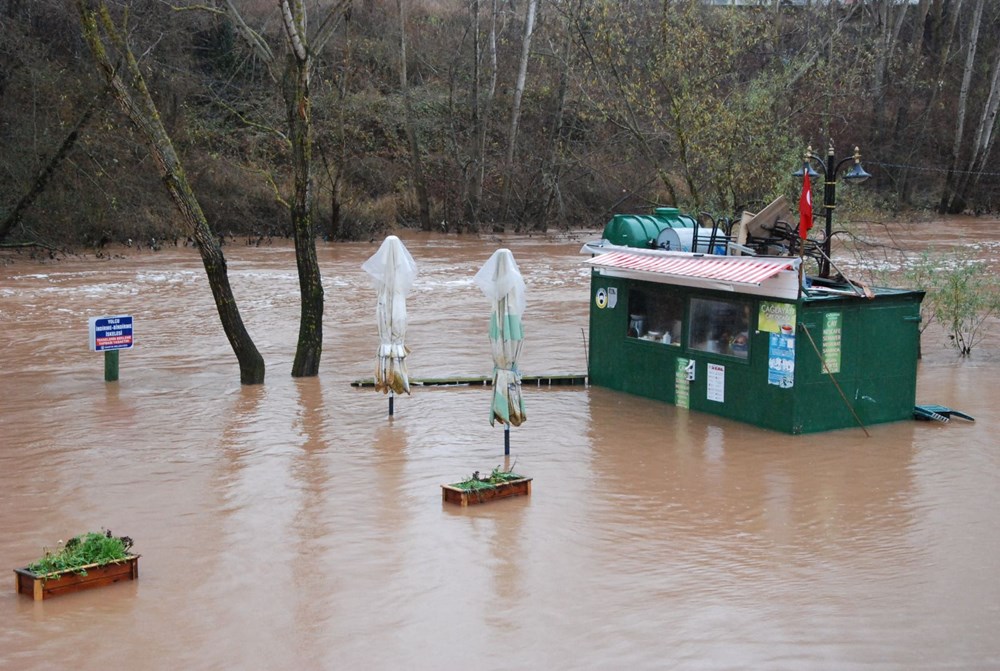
580;240;801;300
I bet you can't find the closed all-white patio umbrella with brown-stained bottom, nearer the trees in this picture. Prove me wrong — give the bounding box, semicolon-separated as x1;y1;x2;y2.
361;235;417;400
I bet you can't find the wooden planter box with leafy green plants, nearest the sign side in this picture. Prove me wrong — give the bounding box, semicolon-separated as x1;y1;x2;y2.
14;529;139;601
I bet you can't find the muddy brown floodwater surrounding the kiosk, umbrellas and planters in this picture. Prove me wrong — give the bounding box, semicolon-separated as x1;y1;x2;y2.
0;219;1000;671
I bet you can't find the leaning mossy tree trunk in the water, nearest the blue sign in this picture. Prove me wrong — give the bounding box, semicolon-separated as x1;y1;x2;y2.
77;0;264;384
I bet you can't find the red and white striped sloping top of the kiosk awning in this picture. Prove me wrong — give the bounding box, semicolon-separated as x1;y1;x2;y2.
588;252;795;286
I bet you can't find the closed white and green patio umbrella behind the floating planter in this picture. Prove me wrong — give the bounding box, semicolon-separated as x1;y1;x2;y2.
473;249;527;429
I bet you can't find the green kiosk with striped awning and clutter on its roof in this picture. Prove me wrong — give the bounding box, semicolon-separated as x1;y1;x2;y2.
581;208;924;434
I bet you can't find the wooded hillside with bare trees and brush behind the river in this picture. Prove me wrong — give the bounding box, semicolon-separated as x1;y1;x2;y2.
0;0;1000;249
